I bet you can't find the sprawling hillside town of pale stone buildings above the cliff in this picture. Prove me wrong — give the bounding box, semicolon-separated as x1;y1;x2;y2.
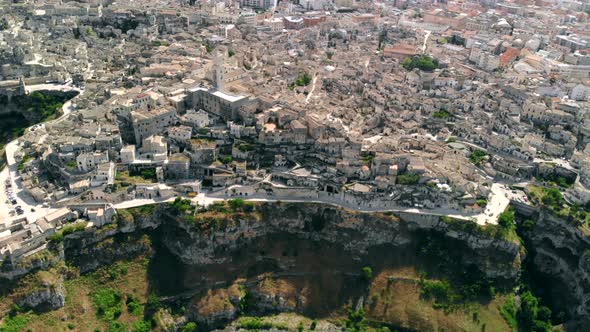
0;0;590;270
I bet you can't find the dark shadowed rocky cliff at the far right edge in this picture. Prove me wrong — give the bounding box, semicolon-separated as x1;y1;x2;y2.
524;210;590;327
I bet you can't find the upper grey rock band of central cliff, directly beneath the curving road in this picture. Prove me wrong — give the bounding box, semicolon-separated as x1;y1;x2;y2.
162;203;521;281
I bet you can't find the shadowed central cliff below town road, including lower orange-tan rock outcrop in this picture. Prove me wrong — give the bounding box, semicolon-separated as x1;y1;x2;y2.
155;203;523;328
